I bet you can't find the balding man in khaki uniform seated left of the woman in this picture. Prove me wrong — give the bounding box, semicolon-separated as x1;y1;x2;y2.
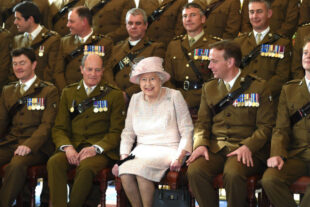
47;54;125;207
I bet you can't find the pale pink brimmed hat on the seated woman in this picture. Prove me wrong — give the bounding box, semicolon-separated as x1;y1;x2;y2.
129;56;170;84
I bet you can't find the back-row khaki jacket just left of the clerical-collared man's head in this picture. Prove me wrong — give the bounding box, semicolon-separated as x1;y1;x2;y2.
85;0;135;43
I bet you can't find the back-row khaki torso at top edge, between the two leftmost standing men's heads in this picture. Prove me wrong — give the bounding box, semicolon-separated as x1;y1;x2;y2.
48;0;84;36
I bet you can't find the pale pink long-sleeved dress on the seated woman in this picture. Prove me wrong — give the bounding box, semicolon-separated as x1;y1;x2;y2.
119;88;193;182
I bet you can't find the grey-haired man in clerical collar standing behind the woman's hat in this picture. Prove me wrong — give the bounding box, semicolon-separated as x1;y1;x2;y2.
104;8;165;98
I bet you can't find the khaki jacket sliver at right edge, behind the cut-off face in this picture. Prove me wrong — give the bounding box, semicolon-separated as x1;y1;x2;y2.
291;24;310;79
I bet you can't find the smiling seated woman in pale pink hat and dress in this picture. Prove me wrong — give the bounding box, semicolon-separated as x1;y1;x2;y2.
113;57;193;207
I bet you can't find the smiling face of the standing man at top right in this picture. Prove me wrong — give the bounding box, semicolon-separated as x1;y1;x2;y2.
249;2;272;32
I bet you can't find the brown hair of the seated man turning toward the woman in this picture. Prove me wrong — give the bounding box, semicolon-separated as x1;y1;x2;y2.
210;40;242;67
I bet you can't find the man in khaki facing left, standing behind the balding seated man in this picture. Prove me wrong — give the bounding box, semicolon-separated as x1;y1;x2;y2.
54;6;113;90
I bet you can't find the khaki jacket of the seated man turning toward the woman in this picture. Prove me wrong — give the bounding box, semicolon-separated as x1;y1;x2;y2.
194;73;275;161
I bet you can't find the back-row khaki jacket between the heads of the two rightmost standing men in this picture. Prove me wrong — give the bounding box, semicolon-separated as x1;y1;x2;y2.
194;0;241;39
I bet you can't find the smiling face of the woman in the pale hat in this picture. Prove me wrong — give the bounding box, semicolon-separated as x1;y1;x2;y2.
139;73;161;100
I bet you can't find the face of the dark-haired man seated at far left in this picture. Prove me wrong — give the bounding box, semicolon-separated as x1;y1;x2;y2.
12;55;37;83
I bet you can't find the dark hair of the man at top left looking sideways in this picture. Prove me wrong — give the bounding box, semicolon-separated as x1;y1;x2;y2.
13;1;41;24
